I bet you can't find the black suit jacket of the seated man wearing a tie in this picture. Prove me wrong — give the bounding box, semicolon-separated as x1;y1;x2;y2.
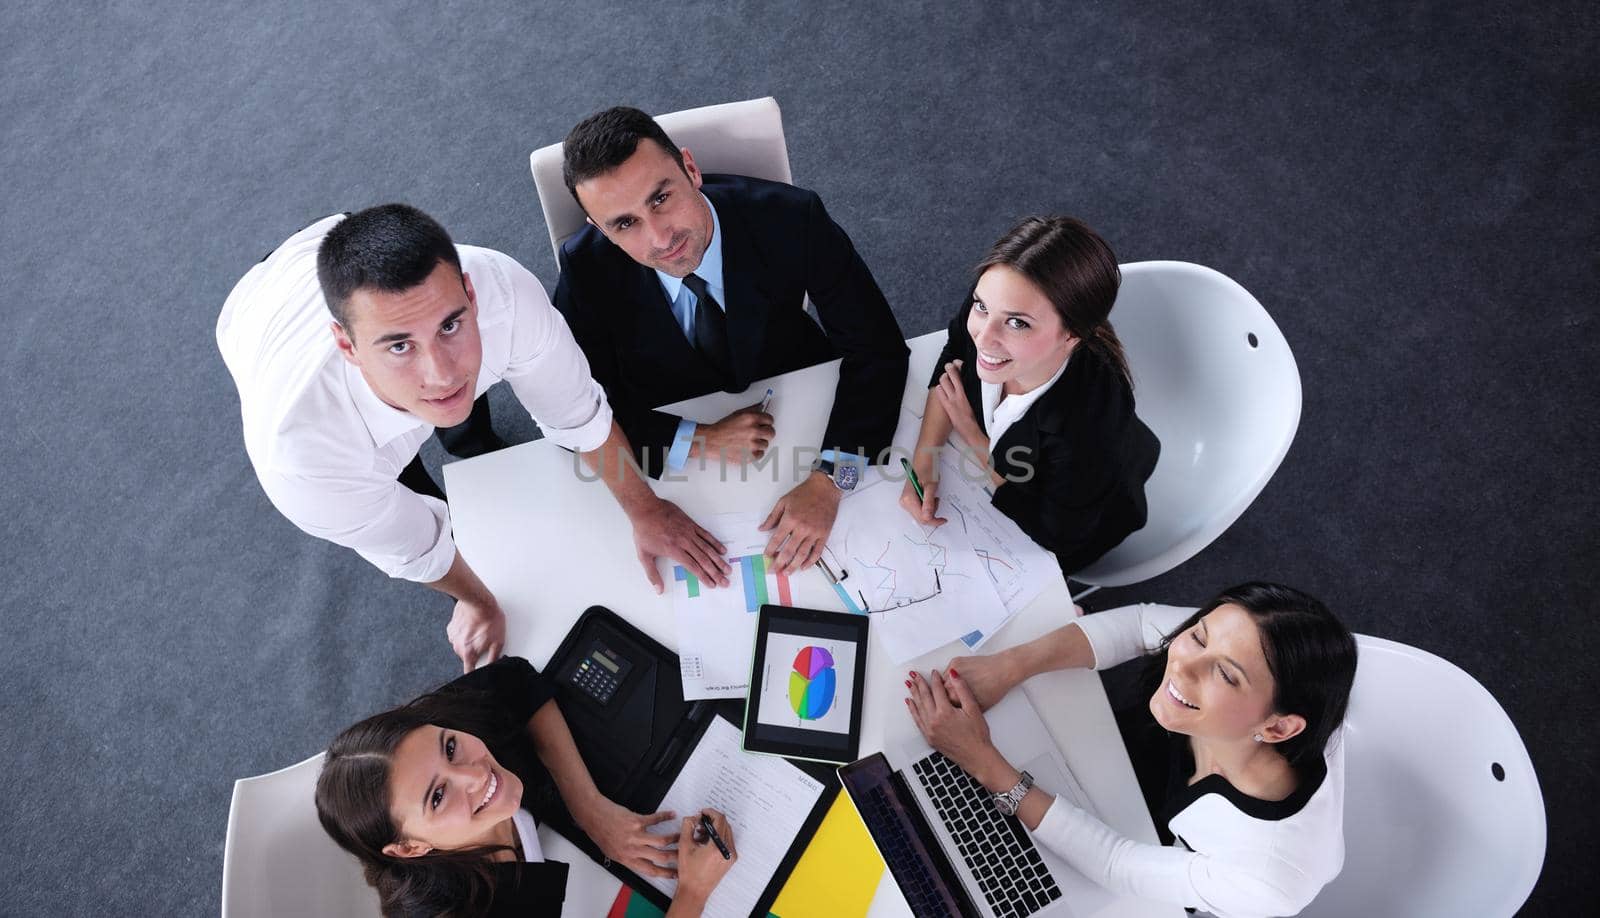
555;174;909;475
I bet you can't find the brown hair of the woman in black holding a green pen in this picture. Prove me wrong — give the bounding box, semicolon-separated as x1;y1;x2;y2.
976;216;1133;385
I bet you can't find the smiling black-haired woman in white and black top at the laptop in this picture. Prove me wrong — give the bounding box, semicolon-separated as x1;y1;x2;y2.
906;582;1355;918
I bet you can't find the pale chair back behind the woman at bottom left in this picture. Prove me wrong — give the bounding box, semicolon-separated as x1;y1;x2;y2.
222;752;381;918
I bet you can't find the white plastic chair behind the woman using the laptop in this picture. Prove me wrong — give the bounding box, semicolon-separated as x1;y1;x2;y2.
1301;635;1546;918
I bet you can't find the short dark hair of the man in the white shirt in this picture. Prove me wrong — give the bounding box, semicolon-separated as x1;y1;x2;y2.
317;205;461;329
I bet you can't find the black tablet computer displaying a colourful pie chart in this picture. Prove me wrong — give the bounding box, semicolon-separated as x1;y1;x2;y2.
744;606;867;764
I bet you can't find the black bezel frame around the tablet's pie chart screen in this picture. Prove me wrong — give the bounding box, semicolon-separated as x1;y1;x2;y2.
744;605;869;764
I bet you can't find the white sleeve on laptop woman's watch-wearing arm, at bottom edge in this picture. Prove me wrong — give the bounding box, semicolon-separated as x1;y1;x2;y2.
1034;796;1320;918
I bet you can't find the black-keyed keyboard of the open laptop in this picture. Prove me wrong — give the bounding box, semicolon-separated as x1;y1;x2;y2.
907;752;1061;918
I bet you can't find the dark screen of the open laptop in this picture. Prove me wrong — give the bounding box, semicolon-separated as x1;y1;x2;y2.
838;753;979;918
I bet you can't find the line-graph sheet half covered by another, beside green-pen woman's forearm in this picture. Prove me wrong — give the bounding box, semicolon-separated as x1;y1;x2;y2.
939;449;1061;648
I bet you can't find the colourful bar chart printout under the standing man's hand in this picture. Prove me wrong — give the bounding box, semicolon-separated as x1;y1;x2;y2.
667;513;794;700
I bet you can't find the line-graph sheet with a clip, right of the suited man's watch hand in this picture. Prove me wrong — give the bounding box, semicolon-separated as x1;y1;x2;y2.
827;469;1006;664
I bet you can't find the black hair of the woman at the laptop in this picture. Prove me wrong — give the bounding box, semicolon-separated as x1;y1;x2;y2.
1142;581;1355;769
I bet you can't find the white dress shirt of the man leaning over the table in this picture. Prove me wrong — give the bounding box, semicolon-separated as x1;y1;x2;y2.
216;214;611;582
